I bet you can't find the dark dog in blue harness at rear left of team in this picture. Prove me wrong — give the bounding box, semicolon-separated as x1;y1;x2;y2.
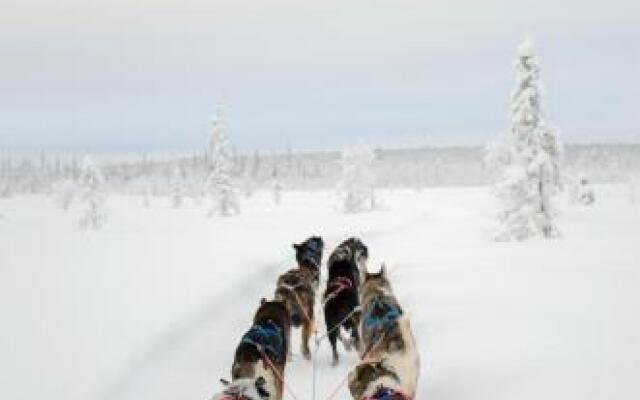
213;299;291;400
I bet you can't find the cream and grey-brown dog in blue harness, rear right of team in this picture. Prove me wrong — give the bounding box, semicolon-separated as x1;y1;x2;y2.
349;265;420;400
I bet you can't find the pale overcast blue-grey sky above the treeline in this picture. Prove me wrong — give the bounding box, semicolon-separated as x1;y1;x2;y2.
0;0;640;151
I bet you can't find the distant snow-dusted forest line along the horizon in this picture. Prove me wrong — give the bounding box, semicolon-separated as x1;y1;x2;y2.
0;144;640;196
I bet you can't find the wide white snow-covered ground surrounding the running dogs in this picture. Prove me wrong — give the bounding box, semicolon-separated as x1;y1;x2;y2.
0;185;640;400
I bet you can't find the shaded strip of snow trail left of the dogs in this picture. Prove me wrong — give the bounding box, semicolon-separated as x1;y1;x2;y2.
98;263;282;400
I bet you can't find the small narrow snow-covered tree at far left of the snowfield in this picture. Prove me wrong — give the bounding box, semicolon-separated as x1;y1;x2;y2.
78;156;106;229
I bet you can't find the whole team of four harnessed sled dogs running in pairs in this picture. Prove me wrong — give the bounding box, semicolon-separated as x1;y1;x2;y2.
213;236;420;400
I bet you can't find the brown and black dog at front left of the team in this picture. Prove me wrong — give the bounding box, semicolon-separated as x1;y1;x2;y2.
275;236;324;359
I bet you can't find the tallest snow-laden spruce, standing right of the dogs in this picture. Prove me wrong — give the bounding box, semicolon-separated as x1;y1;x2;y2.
487;40;562;240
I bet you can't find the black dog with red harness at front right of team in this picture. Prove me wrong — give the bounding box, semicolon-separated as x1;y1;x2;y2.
323;238;369;365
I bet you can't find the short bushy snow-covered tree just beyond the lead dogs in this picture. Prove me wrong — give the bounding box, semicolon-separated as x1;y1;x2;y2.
338;142;376;213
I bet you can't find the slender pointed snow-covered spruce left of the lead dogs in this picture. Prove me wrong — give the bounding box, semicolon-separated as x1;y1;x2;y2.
207;106;240;216
